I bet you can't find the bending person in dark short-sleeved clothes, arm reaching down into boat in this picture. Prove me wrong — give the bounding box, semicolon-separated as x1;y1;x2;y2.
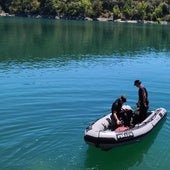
111;95;126;129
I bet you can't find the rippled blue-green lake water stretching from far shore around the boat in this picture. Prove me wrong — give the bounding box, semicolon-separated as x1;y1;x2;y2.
0;17;170;170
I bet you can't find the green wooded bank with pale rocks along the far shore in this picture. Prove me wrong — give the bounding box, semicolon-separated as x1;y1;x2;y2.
0;0;170;24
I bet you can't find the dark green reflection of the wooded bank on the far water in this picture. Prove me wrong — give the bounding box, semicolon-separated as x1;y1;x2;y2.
0;18;170;62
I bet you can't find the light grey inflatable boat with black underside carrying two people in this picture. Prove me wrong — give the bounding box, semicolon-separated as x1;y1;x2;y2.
84;105;167;150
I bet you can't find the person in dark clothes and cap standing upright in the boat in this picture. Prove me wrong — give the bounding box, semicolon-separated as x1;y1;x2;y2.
134;80;149;123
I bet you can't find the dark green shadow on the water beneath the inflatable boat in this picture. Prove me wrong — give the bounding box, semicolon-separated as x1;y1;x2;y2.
85;119;166;170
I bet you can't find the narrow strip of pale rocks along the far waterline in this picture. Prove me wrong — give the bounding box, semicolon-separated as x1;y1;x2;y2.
0;12;170;25
